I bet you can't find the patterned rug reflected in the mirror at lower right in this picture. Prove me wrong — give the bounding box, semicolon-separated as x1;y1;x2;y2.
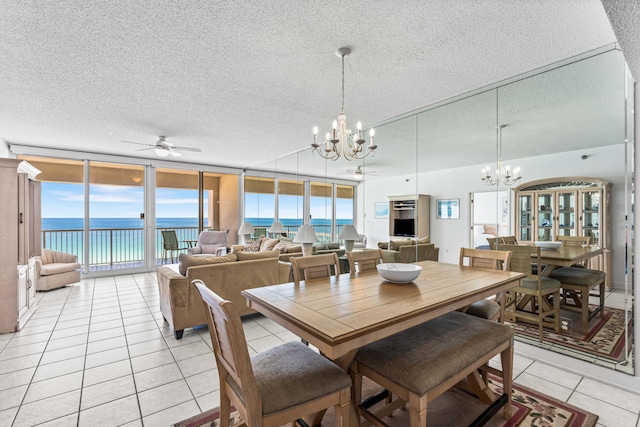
511;307;632;363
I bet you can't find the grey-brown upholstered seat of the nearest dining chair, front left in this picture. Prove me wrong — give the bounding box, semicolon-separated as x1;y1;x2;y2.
242;342;351;415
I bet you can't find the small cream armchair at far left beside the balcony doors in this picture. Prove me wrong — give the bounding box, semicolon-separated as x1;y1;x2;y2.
36;249;80;291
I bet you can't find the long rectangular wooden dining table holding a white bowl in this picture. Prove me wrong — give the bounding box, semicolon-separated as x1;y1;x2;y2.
242;261;525;425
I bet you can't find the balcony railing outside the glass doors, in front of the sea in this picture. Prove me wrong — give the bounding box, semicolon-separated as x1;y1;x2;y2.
42;225;342;271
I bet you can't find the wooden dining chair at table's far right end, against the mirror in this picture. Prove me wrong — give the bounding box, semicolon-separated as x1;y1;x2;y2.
459;248;511;322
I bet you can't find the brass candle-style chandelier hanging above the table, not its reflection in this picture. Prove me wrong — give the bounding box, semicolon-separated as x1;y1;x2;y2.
311;47;378;160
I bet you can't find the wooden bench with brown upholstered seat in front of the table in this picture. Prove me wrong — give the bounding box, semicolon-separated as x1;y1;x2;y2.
350;312;513;426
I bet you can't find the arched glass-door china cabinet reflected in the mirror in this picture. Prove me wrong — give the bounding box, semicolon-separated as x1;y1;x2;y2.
513;177;611;288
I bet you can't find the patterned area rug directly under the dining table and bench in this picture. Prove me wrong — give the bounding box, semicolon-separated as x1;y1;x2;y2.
175;377;598;427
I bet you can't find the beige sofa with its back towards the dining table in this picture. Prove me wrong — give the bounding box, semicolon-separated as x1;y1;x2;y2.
156;251;291;339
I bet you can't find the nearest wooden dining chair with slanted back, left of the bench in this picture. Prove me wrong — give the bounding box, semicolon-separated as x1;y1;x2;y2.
192;280;351;427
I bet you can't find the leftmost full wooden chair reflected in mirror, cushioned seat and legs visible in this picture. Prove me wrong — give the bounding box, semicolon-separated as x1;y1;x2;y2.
496;244;560;342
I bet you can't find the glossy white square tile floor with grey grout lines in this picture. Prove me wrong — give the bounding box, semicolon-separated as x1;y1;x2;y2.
0;273;640;427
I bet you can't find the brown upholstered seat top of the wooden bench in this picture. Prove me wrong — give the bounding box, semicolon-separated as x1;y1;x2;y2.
356;311;513;396
